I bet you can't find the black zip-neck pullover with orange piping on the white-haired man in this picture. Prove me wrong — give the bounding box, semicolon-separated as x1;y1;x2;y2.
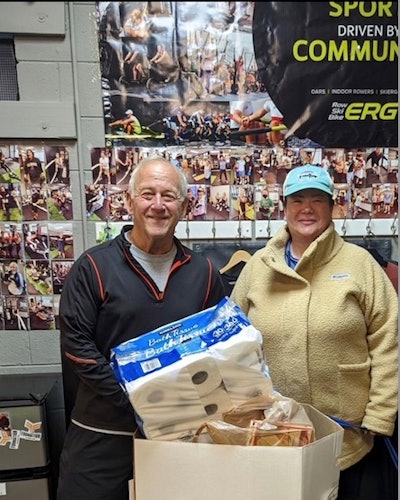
60;226;225;432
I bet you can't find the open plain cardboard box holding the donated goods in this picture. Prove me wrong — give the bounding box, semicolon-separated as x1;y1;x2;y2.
134;405;343;500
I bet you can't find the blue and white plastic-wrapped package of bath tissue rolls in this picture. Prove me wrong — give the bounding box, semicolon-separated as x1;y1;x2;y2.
111;297;273;440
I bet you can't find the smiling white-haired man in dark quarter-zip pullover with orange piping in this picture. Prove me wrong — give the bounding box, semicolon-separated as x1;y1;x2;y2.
57;158;225;500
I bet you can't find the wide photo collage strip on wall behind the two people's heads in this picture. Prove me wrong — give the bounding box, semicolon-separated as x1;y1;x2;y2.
89;146;398;223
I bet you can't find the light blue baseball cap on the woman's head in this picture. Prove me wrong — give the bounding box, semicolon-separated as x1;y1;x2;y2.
283;165;334;198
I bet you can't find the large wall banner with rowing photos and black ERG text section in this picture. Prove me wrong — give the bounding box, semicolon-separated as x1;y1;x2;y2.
96;2;398;148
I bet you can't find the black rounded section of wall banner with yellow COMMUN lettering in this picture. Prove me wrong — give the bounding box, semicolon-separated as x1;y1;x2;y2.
253;2;398;147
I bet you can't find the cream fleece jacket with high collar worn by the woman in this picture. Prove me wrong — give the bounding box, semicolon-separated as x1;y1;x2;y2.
231;222;398;469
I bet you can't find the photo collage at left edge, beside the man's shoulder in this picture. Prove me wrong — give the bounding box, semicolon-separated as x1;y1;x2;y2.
0;145;74;330
